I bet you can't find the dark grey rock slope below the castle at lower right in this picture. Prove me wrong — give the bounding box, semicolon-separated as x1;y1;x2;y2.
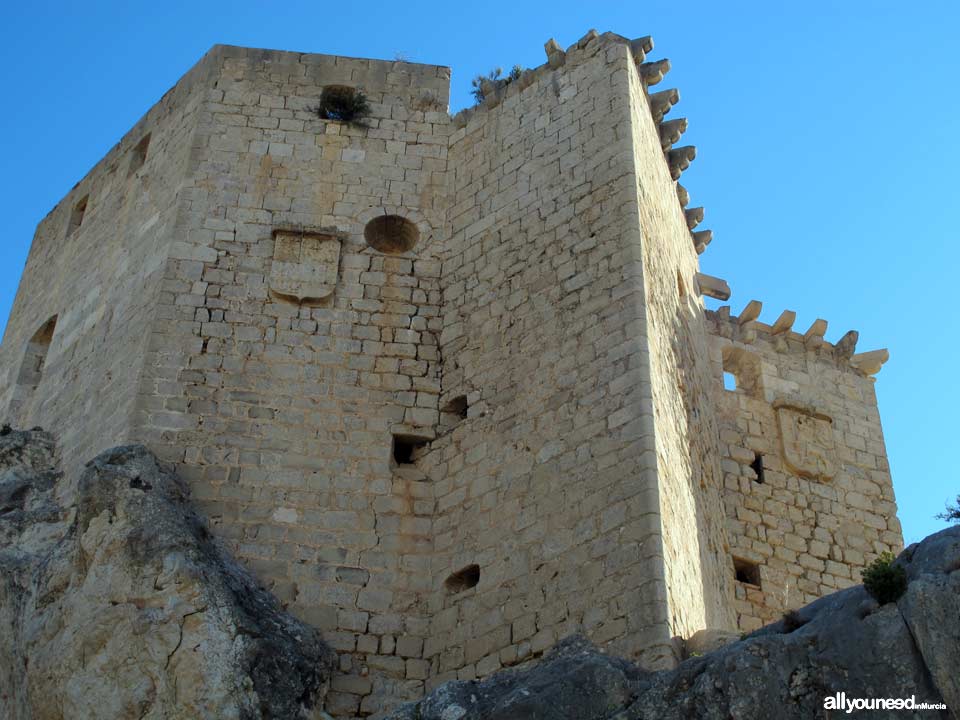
390;527;960;720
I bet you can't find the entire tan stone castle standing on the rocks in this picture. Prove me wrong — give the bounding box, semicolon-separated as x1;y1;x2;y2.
0;31;902;716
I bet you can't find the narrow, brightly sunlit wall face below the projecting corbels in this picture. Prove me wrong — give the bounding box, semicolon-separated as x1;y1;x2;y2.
628;43;735;658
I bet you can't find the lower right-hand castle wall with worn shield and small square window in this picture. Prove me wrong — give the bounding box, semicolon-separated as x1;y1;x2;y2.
710;308;903;631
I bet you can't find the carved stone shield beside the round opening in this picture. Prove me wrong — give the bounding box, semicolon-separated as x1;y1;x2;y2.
270;230;340;302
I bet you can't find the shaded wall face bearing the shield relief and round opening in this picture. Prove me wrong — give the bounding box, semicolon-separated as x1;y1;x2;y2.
127;47;449;716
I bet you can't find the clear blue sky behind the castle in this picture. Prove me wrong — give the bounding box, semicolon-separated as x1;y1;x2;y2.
0;0;960;542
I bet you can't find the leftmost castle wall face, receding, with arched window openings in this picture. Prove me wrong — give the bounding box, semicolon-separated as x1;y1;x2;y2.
0;53;212;476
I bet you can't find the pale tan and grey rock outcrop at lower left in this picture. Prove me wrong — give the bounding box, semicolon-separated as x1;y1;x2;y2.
0;428;335;720
